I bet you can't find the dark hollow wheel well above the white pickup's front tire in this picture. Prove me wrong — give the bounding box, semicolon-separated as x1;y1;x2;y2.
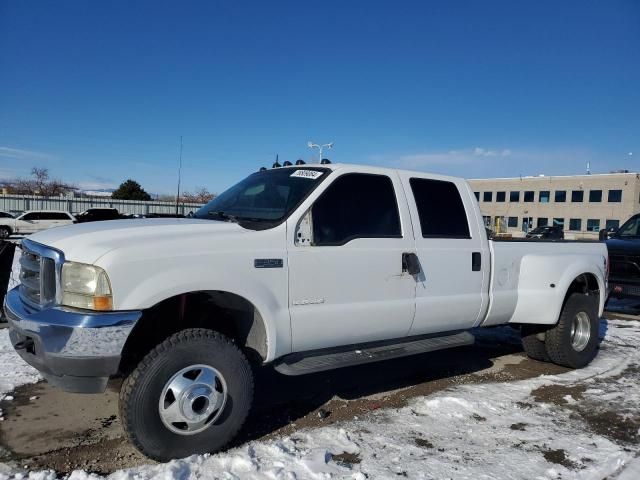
120;290;268;375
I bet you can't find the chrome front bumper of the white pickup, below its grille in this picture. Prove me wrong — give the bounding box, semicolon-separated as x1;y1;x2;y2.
4;287;142;393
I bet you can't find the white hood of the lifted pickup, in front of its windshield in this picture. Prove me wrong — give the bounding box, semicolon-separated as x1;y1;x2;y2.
29;218;245;263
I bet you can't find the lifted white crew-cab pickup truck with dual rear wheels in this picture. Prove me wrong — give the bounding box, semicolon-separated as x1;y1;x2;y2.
5;164;608;460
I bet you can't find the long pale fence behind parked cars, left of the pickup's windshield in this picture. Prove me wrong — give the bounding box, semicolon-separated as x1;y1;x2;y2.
0;195;202;215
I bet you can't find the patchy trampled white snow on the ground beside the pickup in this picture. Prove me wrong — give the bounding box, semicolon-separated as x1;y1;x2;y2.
0;320;640;480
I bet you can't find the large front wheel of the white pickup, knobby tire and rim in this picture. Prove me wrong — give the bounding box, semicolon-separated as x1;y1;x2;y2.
120;328;253;461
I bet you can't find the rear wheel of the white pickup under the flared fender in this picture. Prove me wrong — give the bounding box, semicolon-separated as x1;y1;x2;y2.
545;293;600;368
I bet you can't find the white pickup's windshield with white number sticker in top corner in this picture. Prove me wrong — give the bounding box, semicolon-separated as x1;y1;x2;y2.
194;168;329;229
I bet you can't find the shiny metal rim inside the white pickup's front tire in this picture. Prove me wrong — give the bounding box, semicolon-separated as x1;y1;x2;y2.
158;365;227;435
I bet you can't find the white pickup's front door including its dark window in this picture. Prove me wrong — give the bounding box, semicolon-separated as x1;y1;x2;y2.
287;173;416;352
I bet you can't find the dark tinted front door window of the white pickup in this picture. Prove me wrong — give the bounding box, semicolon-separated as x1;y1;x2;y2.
311;173;402;246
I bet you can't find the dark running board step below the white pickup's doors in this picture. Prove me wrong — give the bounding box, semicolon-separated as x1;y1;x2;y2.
275;332;475;375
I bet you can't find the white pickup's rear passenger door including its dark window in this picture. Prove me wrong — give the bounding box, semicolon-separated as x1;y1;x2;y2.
400;173;489;335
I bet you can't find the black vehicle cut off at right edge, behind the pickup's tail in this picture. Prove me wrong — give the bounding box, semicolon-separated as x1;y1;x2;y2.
606;214;640;299
